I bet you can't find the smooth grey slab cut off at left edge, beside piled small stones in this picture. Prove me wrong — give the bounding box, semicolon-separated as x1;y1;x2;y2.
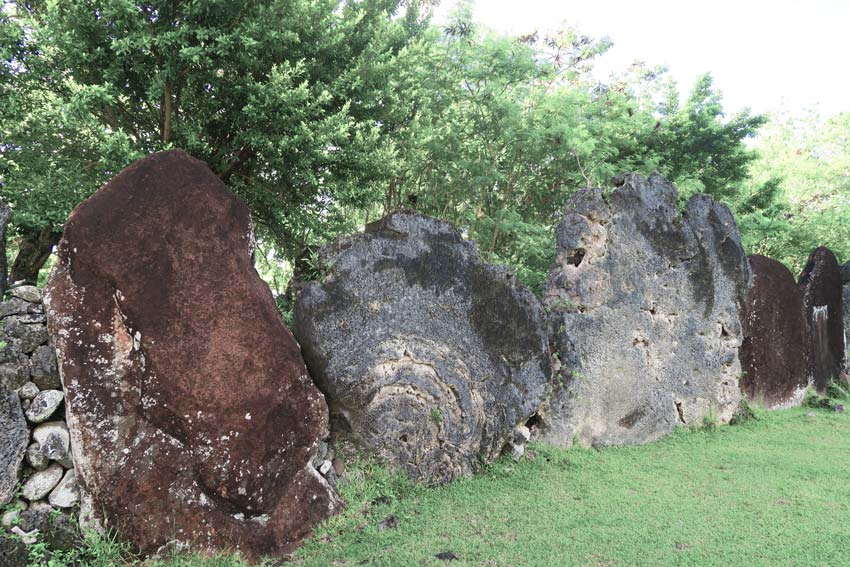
0;388;29;508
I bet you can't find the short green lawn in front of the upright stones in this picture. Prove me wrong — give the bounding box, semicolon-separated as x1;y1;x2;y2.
26;408;850;567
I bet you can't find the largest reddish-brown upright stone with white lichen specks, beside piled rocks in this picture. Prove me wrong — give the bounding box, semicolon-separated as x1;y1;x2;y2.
46;151;338;557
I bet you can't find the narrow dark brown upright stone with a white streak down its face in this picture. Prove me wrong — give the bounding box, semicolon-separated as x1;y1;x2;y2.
797;246;844;394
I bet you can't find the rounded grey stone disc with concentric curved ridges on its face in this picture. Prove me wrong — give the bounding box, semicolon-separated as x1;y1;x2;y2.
295;213;549;482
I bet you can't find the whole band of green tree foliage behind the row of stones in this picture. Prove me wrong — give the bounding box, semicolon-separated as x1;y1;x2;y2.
0;0;850;287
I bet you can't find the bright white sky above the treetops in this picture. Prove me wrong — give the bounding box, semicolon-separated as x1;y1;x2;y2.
435;0;850;117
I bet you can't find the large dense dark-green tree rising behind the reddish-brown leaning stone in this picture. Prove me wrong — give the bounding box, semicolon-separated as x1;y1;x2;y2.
0;0;427;279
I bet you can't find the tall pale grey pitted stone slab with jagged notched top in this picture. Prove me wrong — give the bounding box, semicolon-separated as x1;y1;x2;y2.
541;174;750;445
